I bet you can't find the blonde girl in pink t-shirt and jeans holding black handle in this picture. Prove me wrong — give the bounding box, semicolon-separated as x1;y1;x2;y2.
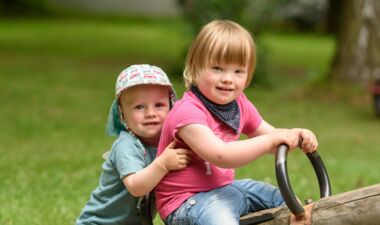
156;20;317;225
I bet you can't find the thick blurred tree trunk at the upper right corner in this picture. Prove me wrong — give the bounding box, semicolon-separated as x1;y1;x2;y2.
330;0;380;82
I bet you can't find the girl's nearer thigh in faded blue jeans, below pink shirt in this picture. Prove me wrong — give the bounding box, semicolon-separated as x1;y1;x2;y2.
166;185;244;225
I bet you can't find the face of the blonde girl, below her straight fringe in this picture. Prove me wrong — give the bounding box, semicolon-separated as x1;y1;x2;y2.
196;63;248;105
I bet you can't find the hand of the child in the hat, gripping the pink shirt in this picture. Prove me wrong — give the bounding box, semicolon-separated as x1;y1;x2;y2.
160;141;191;171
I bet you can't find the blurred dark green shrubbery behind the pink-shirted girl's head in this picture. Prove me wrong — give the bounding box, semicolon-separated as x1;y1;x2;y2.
178;0;327;85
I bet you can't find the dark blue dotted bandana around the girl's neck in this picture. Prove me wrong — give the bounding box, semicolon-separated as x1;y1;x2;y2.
191;86;240;133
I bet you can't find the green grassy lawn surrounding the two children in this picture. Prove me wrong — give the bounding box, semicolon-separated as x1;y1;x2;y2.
0;16;380;225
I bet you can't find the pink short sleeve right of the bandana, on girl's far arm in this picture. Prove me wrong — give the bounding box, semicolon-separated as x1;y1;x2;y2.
238;94;263;134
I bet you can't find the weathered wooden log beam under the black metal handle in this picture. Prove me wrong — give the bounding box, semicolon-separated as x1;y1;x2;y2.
240;184;380;225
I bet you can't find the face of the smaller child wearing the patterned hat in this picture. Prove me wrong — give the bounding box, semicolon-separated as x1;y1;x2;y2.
119;84;170;146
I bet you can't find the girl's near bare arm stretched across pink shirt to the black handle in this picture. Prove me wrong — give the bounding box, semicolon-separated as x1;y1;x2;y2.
177;122;308;168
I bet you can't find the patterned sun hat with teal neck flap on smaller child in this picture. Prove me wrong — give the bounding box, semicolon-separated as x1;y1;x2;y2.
106;64;176;136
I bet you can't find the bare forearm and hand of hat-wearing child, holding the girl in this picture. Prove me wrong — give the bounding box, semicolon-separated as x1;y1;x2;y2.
123;141;190;197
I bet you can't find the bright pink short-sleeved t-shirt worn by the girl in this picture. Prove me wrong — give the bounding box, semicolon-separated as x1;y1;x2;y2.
156;91;262;219
